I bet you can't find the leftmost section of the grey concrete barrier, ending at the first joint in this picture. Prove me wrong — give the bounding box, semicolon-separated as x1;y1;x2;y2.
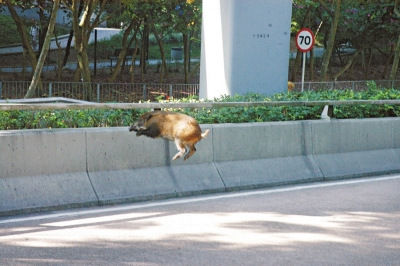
0;129;97;213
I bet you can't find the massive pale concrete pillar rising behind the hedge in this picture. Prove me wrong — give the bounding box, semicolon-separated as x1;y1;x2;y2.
200;0;292;99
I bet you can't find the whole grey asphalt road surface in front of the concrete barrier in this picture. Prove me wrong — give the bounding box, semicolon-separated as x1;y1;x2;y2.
0;175;400;265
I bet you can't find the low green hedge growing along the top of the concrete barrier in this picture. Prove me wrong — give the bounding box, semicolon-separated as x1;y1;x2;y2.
0;83;400;130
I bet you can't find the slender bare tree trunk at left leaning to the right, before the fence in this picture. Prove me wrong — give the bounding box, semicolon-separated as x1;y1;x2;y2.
25;0;60;98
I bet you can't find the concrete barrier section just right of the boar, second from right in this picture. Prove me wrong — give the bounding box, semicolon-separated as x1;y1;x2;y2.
213;122;322;190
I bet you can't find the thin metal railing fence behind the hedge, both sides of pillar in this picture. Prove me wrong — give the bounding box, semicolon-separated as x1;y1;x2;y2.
0;80;400;103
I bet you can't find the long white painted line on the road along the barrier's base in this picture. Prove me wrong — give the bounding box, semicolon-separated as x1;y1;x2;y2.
0;175;400;224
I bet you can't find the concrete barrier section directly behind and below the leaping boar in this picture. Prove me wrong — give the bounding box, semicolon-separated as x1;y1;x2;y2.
87;127;224;203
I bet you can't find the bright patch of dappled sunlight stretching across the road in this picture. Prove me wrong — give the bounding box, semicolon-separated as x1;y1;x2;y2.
0;212;400;248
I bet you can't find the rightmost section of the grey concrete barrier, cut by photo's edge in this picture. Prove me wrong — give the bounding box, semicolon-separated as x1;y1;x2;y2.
311;118;400;179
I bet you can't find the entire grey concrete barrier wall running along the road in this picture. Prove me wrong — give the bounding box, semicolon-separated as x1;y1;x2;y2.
0;118;400;216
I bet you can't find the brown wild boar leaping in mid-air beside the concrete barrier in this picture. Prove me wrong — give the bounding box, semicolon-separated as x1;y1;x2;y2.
129;111;209;160
